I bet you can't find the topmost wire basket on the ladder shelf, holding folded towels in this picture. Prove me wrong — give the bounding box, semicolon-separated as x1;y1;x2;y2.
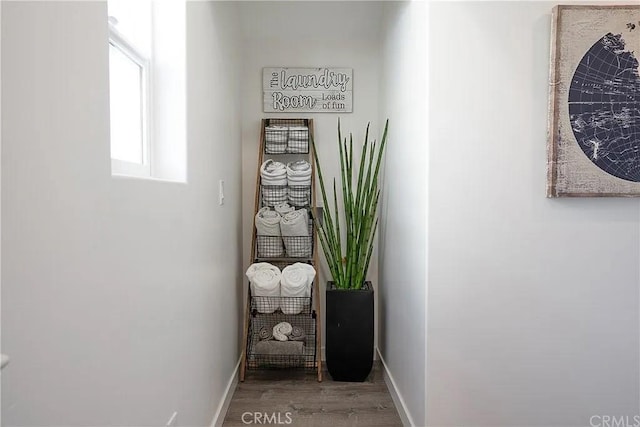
264;119;309;154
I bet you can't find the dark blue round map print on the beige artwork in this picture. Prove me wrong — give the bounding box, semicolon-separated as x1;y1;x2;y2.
569;33;640;182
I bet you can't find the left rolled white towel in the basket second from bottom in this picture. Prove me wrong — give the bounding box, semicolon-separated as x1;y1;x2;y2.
246;262;282;313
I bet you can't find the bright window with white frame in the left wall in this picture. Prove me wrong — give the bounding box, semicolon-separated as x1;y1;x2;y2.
107;0;186;182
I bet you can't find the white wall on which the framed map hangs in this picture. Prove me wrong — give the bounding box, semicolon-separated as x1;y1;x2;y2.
426;2;640;426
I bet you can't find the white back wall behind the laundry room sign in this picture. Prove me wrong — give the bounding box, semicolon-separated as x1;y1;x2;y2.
240;1;382;358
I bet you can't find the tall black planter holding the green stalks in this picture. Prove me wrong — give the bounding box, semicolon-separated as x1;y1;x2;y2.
325;282;373;382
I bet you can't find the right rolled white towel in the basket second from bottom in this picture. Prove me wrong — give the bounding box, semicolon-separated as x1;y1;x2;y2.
280;262;316;314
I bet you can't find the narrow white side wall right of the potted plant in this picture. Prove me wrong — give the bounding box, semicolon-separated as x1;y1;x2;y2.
379;2;428;426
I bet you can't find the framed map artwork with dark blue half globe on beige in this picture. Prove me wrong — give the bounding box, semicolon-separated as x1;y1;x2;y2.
547;5;640;197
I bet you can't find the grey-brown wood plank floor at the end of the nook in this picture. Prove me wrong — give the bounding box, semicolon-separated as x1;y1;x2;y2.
223;364;402;427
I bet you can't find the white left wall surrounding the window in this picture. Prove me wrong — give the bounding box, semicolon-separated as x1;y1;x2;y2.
2;2;241;426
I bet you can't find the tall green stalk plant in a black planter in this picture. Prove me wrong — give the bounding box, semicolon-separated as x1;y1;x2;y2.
312;120;389;381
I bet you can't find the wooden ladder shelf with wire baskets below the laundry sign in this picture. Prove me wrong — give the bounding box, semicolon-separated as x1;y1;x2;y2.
240;118;322;381
